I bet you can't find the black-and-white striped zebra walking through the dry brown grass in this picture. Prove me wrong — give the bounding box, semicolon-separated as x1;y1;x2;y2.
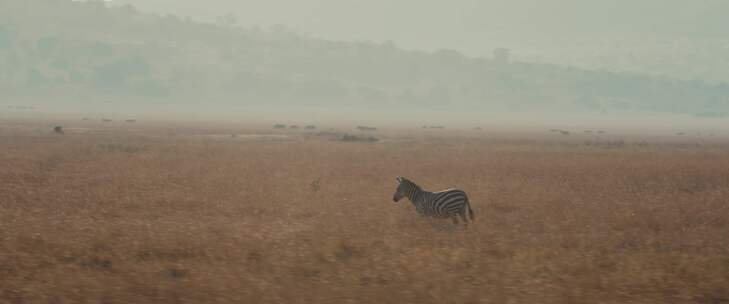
392;176;474;224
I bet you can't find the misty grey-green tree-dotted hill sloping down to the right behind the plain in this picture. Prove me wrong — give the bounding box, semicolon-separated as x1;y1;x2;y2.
0;0;729;117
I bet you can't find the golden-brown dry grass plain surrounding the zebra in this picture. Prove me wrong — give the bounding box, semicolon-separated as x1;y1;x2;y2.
0;121;729;304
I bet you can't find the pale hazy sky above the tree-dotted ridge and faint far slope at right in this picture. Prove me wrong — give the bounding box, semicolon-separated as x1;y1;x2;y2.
113;0;729;55
